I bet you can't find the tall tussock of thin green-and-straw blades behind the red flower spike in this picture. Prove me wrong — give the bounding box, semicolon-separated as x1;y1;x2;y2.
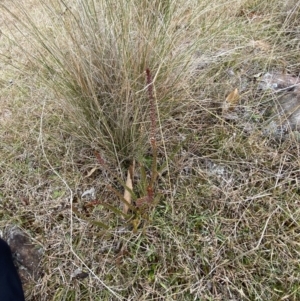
2;0;212;162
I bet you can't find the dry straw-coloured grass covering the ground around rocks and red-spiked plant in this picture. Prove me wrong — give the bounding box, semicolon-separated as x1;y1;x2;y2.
0;0;300;301
